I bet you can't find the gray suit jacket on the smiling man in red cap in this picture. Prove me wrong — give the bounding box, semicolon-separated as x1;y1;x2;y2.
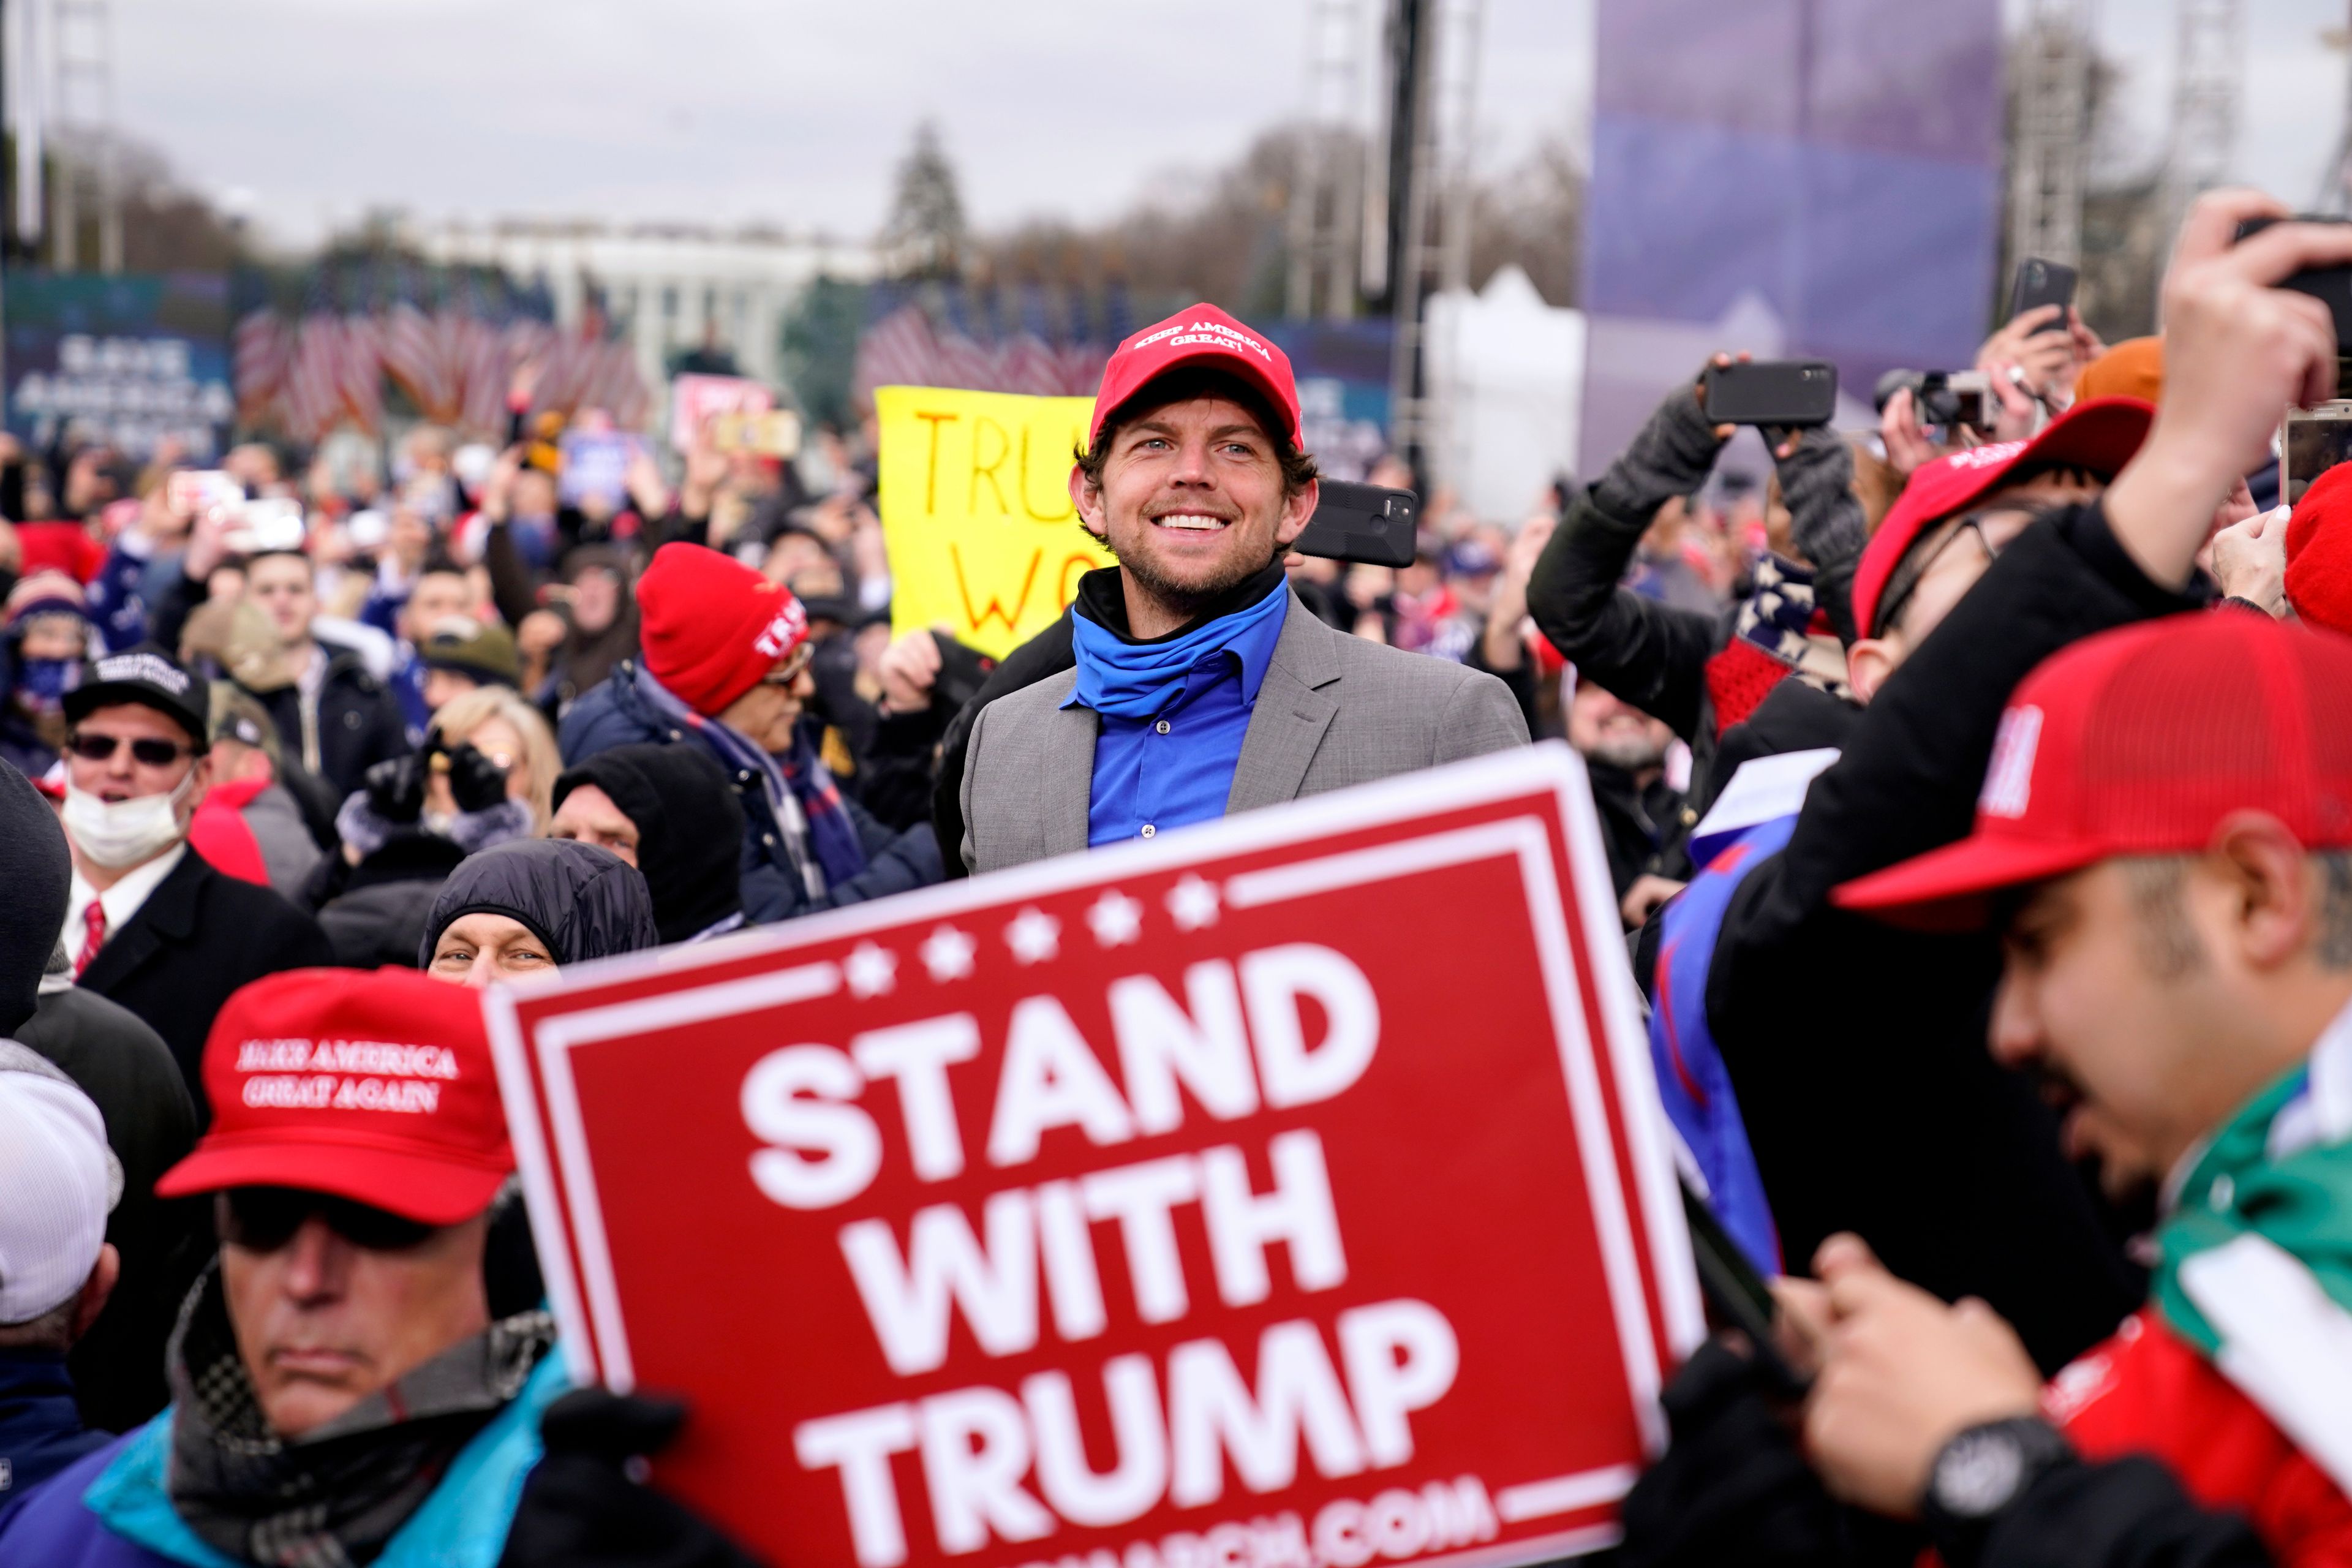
962;595;1526;872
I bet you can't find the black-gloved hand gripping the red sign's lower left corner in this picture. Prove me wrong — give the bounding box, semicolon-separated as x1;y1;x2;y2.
499;1389;760;1568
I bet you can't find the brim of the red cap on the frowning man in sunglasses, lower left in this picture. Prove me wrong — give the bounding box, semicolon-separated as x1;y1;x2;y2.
155;1128;508;1225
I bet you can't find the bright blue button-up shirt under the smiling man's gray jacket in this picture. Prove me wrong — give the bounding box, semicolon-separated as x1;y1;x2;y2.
1063;590;1289;846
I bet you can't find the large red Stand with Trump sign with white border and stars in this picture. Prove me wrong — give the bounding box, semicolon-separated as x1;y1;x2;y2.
487;745;1703;1568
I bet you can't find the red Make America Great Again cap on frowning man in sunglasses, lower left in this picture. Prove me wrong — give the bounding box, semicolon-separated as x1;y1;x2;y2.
155;968;515;1225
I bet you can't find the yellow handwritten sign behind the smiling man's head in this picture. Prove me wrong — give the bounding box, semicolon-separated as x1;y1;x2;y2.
875;385;1110;658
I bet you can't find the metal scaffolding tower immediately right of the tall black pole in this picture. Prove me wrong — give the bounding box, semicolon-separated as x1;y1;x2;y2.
1366;0;1484;480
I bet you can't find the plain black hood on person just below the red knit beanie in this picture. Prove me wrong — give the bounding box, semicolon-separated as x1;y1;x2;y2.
555;745;743;943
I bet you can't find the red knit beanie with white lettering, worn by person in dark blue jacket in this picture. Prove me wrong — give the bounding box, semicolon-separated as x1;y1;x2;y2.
638;543;809;717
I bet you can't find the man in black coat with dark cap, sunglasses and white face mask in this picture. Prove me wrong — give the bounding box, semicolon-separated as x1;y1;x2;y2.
61;649;334;1126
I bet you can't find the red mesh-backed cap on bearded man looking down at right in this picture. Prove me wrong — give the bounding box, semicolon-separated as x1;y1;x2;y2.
1832;609;2352;926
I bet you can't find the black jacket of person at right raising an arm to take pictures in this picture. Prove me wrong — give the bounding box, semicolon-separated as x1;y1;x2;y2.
1708;503;2201;1373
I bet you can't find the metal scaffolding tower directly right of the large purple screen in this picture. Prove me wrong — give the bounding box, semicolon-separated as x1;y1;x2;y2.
2008;0;2098;266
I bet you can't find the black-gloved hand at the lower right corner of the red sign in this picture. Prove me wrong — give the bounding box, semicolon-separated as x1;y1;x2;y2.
1616;1340;1851;1568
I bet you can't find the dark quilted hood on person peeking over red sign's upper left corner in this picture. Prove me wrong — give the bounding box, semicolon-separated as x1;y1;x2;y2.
417;839;661;968
